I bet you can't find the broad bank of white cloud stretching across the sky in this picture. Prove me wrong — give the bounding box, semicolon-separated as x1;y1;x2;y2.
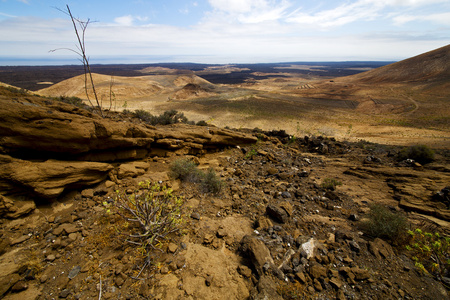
0;0;450;63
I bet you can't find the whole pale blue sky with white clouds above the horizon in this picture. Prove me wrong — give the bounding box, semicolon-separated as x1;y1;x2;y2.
0;0;450;65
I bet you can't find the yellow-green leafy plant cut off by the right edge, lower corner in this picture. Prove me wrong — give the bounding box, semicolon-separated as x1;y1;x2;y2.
406;228;450;288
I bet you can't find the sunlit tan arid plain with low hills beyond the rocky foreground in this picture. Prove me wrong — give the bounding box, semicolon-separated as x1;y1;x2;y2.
28;46;450;148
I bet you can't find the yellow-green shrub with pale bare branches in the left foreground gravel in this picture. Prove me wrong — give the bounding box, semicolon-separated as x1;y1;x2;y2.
108;181;184;277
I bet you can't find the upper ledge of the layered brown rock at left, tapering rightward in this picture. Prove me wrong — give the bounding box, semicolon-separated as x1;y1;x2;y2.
0;96;256;161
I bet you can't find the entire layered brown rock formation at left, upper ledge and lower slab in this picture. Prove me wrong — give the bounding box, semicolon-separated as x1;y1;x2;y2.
0;89;256;210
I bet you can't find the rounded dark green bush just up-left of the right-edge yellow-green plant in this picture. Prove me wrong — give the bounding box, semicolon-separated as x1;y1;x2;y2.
360;204;408;241
